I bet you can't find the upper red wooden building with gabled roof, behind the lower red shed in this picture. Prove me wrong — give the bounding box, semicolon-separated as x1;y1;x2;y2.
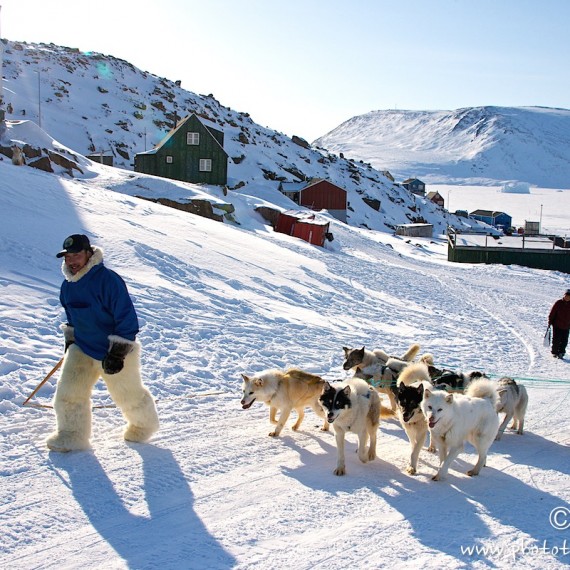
279;178;347;223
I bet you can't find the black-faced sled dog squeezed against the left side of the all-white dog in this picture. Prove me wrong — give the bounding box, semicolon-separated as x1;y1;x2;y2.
392;362;435;475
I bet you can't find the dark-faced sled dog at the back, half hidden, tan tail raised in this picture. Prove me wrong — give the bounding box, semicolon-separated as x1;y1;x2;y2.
342;344;420;412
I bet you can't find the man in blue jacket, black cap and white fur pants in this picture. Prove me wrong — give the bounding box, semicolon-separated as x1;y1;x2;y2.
46;234;158;452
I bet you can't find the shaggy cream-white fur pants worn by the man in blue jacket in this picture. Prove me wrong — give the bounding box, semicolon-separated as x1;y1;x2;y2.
47;343;158;451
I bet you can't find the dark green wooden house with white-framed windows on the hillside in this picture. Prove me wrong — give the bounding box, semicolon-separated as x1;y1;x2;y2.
135;114;228;186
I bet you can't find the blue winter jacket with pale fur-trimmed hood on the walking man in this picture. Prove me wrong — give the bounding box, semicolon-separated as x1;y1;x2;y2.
59;247;139;360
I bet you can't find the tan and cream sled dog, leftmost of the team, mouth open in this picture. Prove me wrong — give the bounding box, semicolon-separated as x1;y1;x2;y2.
241;368;329;437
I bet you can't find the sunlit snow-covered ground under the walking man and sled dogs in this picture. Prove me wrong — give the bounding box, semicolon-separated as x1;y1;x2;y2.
0;153;570;570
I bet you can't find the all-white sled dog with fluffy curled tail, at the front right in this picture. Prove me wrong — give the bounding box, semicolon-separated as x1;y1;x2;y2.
421;378;499;481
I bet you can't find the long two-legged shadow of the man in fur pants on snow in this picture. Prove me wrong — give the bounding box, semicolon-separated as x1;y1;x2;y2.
50;444;235;569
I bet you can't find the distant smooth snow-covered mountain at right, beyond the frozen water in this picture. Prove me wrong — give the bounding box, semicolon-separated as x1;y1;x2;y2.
314;107;570;188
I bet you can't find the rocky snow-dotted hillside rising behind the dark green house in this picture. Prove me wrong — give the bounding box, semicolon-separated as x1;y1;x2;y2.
0;40;454;232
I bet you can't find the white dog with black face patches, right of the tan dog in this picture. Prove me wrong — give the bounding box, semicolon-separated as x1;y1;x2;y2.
319;378;382;475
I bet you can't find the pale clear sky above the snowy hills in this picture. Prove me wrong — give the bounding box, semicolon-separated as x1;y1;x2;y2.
0;0;570;141
